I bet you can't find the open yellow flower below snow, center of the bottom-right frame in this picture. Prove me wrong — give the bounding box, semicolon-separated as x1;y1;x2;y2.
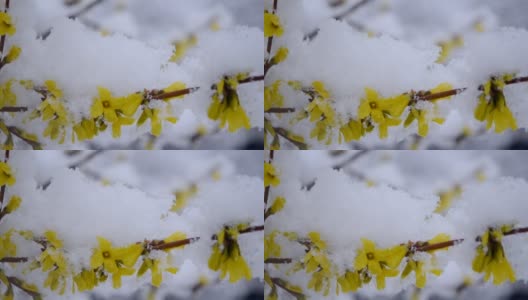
354;238;407;290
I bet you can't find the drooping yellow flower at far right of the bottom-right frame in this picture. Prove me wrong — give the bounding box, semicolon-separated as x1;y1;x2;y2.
473;226;515;285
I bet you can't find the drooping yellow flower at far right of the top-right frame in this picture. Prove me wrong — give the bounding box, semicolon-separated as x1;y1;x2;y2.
474;74;517;133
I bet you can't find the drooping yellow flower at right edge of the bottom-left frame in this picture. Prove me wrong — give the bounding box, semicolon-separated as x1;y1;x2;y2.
208;225;251;283
